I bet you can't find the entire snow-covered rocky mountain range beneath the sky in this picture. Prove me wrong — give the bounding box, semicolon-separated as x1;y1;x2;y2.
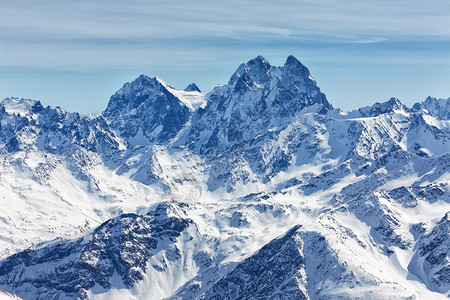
0;56;450;300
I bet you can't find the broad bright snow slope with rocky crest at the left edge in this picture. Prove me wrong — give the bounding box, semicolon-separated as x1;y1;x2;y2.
0;99;163;257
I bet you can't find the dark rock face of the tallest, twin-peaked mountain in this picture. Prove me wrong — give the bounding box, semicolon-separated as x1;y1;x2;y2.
186;56;332;149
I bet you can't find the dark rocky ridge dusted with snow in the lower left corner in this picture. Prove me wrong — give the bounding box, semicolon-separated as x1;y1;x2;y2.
0;204;192;300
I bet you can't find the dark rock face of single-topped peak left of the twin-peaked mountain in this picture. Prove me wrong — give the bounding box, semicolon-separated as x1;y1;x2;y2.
103;75;190;145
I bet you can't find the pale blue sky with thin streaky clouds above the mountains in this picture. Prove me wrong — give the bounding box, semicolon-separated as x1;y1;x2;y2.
0;0;450;113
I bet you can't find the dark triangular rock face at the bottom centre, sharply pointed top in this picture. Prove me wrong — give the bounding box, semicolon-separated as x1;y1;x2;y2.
201;227;307;299
